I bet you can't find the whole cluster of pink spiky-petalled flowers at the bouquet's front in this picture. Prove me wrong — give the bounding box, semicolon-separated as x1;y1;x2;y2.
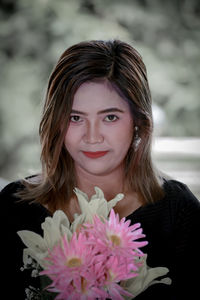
41;210;147;300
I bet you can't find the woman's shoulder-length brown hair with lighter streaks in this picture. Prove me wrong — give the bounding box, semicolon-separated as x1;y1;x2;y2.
21;40;163;212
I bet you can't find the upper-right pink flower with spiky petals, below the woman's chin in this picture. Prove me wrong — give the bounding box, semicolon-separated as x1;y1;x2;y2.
85;209;147;269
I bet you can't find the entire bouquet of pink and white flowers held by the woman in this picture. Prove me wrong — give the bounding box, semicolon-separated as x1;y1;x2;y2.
18;187;170;300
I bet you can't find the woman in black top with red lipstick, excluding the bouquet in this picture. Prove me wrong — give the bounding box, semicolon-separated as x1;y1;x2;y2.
1;40;200;300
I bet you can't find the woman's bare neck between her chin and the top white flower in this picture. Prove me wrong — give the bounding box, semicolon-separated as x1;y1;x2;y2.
76;168;124;200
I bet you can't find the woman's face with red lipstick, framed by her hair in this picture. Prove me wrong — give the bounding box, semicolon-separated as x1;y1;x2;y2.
64;81;133;176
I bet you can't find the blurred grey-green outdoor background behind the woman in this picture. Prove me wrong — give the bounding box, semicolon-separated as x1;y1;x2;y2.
0;0;200;199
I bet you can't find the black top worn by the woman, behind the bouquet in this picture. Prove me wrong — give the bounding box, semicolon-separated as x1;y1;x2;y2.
1;180;200;300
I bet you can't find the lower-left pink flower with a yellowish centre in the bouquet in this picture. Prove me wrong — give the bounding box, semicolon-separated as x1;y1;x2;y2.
40;233;102;299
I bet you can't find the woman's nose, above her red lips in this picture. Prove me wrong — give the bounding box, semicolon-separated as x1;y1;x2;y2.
84;122;104;144
